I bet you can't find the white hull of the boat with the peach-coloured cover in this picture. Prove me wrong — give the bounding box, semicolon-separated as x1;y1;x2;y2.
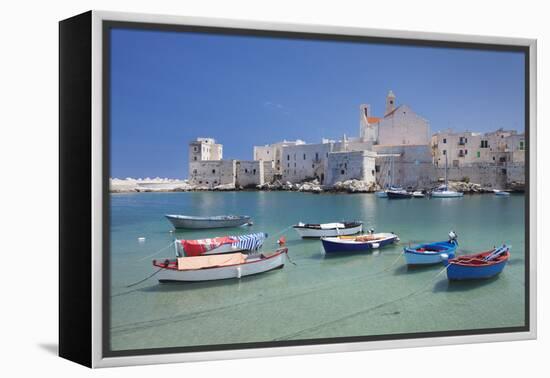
158;250;286;282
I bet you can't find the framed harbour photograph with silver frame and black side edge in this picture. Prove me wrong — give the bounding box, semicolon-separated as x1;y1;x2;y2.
59;11;536;367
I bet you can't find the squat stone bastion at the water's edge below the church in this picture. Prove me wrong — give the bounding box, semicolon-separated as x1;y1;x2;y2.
326;151;376;186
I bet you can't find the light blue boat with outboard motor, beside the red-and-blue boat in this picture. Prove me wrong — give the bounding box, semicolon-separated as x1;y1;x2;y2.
403;231;458;265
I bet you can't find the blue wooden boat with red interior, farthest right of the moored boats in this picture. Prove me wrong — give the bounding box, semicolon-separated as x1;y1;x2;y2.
447;245;510;280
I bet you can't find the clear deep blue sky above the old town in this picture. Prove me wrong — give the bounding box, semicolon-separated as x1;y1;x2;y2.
111;29;524;178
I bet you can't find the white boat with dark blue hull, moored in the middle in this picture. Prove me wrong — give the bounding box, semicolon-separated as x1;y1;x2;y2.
321;232;399;253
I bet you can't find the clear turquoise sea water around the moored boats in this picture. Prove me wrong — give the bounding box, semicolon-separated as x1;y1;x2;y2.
111;192;525;350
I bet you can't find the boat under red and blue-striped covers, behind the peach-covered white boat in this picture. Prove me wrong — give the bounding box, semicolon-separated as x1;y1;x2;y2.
176;232;268;256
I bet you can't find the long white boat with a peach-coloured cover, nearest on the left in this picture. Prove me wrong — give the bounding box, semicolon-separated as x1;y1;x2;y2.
153;248;288;282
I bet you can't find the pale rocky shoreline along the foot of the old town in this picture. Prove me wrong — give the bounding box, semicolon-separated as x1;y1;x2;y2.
110;177;521;194
